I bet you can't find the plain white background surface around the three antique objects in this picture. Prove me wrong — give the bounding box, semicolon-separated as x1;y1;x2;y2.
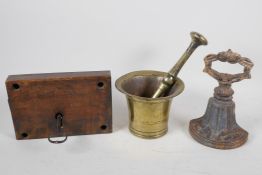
0;0;262;175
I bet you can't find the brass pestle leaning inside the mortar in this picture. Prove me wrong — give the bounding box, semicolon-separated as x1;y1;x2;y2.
152;32;208;98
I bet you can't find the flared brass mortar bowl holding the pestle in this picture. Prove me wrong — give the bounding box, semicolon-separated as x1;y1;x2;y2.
116;70;184;139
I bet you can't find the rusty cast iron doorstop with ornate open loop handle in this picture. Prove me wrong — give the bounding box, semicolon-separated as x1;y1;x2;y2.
189;50;253;149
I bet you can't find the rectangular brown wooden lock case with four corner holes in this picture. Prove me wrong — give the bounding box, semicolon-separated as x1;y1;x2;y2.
6;71;112;139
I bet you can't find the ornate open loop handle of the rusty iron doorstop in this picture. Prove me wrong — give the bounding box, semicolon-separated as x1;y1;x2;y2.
203;49;254;84
